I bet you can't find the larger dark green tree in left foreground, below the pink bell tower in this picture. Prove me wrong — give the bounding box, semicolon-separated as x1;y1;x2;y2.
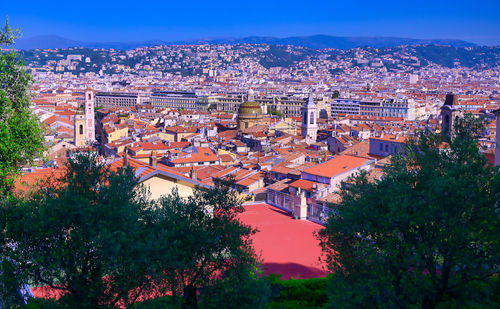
7;153;149;308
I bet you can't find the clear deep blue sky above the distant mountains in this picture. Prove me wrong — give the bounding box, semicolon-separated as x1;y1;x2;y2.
0;0;500;45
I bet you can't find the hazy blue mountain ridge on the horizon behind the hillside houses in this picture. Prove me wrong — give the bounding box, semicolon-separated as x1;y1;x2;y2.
9;35;476;50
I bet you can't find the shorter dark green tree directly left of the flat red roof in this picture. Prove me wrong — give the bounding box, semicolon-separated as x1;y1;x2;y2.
148;181;262;307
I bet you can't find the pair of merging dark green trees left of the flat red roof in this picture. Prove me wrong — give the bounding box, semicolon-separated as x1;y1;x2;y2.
6;153;269;308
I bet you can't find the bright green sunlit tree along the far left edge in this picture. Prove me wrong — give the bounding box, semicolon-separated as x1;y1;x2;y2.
0;18;43;307
